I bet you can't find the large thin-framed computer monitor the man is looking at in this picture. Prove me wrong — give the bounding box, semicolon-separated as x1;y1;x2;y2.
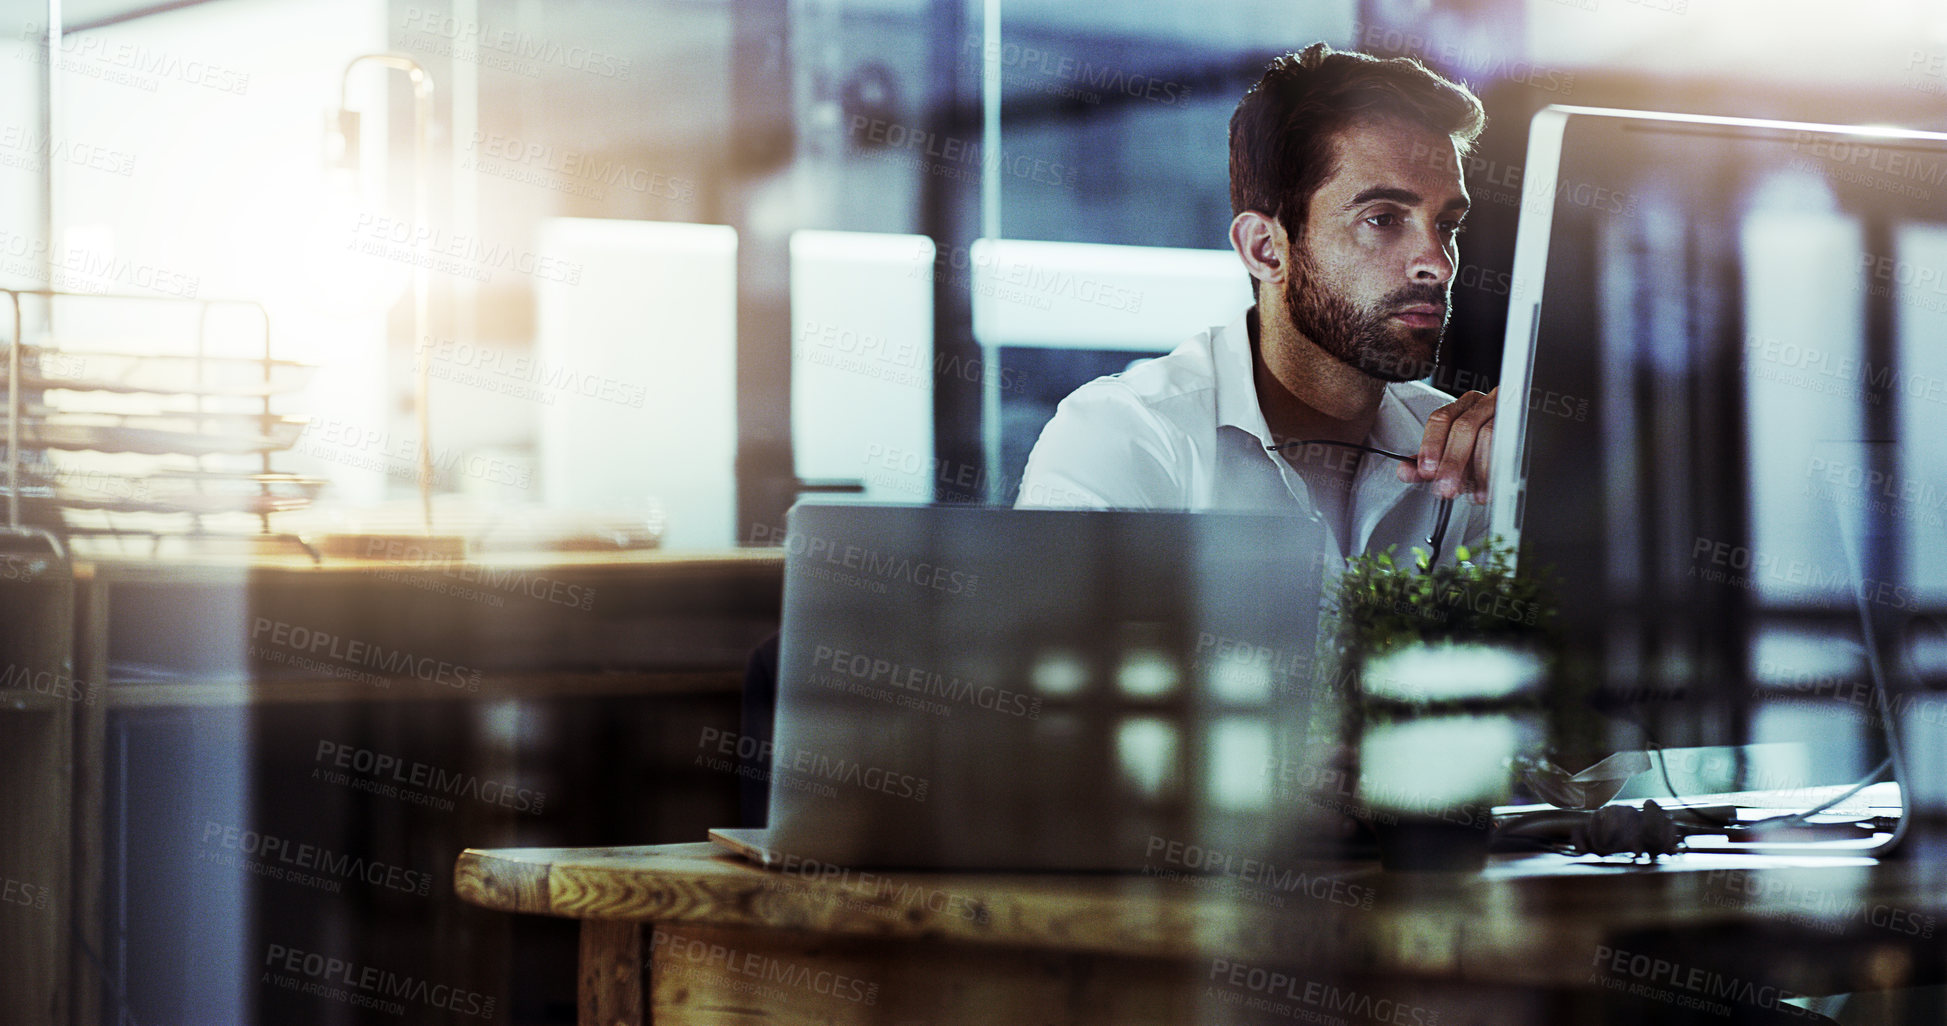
1491;107;1947;833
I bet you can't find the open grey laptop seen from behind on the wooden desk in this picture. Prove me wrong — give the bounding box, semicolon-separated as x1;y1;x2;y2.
711;502;1336;872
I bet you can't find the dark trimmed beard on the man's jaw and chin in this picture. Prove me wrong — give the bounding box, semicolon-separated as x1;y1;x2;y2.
1285;239;1447;382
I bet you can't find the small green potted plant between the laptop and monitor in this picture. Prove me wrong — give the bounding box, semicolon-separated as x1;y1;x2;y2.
1330;539;1558;870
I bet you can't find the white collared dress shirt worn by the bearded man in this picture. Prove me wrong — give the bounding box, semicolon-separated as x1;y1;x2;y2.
1014;311;1488;563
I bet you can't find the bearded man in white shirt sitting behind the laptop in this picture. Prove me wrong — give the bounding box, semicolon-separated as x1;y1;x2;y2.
1016;43;1493;561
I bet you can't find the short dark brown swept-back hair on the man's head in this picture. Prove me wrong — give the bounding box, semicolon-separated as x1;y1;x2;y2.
1231;43;1488;241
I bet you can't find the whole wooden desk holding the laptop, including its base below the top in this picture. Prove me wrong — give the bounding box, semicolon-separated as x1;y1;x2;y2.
454;843;1947;1026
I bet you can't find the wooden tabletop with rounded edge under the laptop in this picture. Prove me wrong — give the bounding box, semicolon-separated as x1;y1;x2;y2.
456;843;1947;993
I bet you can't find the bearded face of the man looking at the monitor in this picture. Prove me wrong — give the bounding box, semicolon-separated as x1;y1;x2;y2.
1285;121;1468;382
